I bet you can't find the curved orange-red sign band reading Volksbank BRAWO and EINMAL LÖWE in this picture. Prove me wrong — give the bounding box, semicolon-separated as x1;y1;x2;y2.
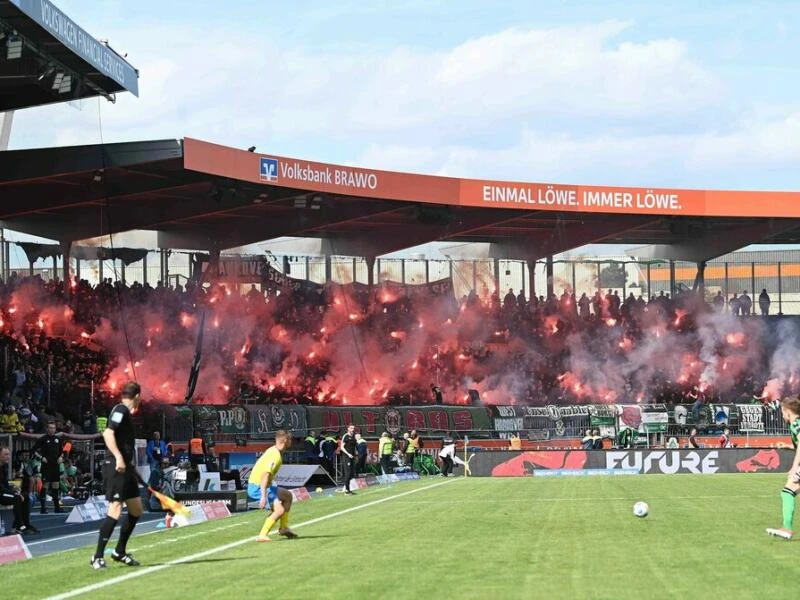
183;138;800;218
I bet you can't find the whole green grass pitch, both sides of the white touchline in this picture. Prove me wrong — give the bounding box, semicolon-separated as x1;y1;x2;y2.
0;475;800;600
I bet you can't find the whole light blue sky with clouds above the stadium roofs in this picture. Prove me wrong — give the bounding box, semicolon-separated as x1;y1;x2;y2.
11;0;800;189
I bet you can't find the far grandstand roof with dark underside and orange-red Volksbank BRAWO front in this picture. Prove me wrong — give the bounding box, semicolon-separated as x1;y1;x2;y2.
0;138;800;260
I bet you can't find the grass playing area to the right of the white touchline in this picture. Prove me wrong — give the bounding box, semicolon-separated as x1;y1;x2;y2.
106;475;797;599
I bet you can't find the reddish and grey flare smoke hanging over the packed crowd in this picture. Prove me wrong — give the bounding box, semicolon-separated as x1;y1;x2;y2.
3;276;800;404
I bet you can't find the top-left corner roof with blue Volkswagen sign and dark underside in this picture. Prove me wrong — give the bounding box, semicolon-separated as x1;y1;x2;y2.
0;0;139;112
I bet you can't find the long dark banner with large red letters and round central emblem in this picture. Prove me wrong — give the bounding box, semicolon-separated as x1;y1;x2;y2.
306;406;492;436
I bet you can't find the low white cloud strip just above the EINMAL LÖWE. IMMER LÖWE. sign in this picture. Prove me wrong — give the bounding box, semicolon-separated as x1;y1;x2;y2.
357;113;800;188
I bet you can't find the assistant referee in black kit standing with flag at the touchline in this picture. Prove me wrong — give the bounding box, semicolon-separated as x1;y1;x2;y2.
90;381;142;570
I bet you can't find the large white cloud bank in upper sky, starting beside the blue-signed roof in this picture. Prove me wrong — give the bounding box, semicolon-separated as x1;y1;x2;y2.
12;21;723;147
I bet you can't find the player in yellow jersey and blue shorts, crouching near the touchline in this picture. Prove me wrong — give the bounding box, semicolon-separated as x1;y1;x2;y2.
247;429;297;542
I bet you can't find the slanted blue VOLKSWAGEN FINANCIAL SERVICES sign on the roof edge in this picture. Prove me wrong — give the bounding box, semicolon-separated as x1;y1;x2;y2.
11;0;139;96
